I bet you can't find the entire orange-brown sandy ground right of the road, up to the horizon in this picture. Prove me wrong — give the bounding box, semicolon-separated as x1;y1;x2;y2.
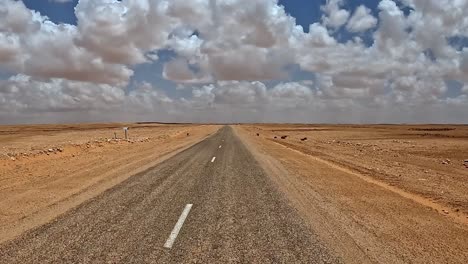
236;125;468;263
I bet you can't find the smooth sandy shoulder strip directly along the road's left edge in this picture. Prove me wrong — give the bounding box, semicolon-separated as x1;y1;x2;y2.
0;126;220;243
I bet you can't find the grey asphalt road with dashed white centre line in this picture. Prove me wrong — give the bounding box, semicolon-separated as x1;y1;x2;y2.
0;127;340;263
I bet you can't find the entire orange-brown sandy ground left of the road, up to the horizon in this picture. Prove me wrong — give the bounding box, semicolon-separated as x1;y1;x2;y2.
0;124;220;242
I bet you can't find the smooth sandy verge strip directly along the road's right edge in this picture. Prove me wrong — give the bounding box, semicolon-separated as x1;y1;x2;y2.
235;126;468;263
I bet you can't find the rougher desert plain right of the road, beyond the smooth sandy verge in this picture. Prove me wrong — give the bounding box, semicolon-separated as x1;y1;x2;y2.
244;125;468;218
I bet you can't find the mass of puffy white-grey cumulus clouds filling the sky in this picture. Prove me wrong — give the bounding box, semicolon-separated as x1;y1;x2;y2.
0;0;468;123
